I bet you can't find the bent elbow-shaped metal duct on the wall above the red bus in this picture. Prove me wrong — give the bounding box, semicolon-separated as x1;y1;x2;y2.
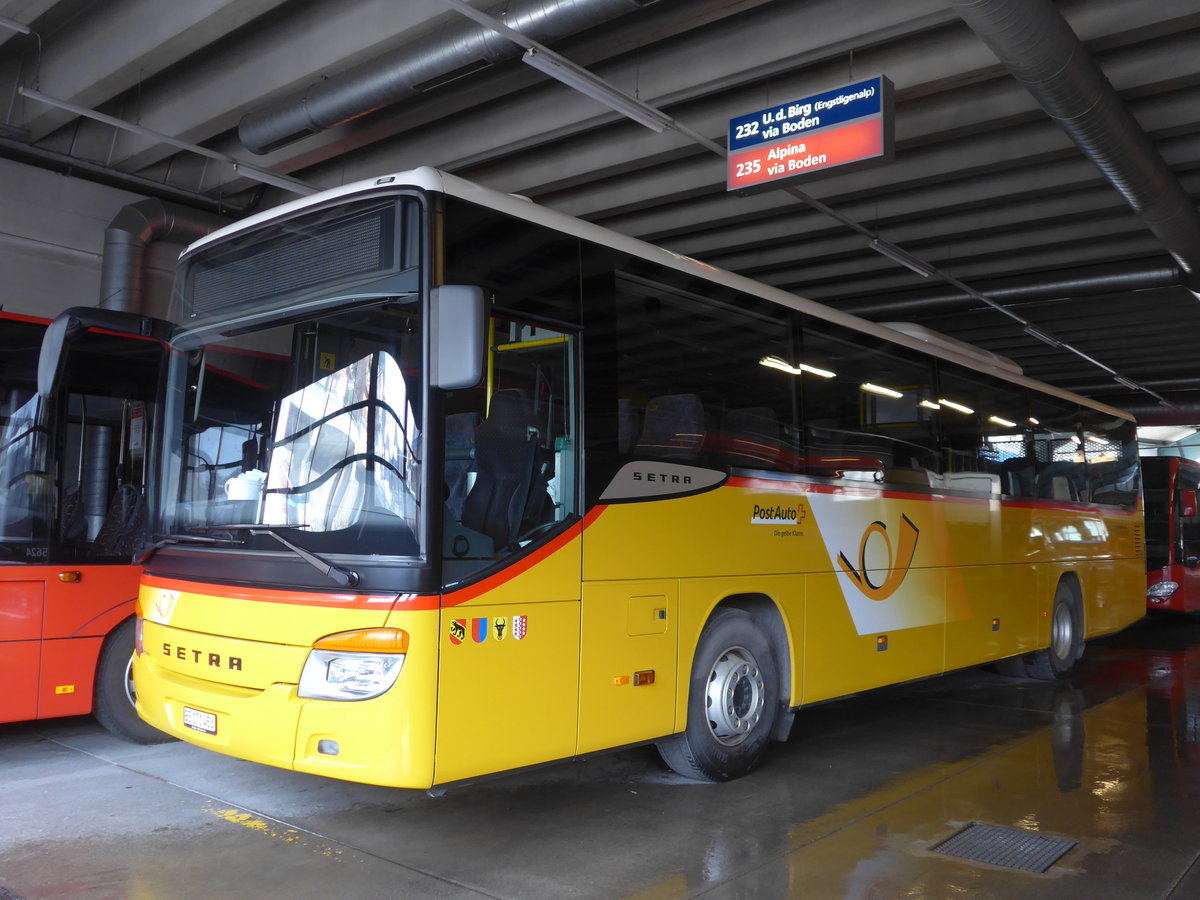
98;199;228;313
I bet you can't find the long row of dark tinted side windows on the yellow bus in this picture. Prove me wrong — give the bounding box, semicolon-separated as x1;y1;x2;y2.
589;267;1138;508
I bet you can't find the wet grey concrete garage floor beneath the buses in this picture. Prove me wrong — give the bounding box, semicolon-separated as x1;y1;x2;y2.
0;617;1200;900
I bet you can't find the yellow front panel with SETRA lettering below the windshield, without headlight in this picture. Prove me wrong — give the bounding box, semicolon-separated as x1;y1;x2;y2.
133;580;438;787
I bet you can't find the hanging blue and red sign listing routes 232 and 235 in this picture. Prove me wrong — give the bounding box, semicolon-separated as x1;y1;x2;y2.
727;76;893;191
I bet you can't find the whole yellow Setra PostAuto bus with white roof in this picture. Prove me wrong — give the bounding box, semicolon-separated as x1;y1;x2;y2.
134;168;1145;788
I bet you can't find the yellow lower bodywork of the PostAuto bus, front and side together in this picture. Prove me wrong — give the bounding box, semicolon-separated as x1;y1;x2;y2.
134;478;1145;787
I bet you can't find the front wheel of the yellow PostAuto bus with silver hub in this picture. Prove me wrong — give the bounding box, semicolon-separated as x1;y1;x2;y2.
658;608;779;781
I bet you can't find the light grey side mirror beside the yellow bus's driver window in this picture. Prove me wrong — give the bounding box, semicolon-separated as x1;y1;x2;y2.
430;284;487;390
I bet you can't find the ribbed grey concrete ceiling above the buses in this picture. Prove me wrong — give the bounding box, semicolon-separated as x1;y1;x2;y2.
0;0;1200;422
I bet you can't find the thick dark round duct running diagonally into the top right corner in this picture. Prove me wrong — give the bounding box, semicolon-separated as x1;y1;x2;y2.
949;0;1200;298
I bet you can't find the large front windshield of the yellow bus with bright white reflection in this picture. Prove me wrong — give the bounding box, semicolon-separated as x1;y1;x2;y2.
157;299;422;556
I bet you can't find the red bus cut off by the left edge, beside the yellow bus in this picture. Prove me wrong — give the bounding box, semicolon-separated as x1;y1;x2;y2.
0;308;167;743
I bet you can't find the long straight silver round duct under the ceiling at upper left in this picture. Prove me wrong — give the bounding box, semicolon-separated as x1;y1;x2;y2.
238;0;653;154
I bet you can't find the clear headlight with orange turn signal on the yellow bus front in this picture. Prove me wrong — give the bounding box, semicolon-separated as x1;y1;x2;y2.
296;628;408;700
